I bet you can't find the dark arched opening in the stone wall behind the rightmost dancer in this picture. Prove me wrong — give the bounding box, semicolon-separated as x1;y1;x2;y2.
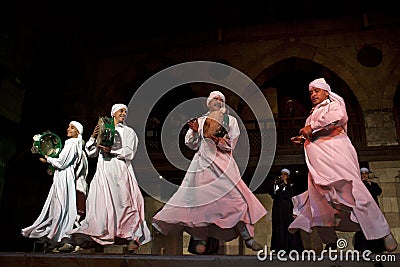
238;57;366;195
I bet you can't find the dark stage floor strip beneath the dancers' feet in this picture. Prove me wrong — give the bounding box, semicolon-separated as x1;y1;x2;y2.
0;252;400;267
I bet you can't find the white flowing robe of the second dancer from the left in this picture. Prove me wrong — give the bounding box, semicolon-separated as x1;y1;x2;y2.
70;123;151;245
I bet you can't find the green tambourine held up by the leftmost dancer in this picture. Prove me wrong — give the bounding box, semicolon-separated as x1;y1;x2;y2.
31;131;62;158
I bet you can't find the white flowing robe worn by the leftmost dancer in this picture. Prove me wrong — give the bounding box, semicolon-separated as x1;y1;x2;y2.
22;138;87;244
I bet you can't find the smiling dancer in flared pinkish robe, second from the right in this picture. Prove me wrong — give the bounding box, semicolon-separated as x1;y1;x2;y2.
153;91;267;254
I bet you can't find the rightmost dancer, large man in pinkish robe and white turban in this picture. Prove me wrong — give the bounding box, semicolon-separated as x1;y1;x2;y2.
289;78;397;251
